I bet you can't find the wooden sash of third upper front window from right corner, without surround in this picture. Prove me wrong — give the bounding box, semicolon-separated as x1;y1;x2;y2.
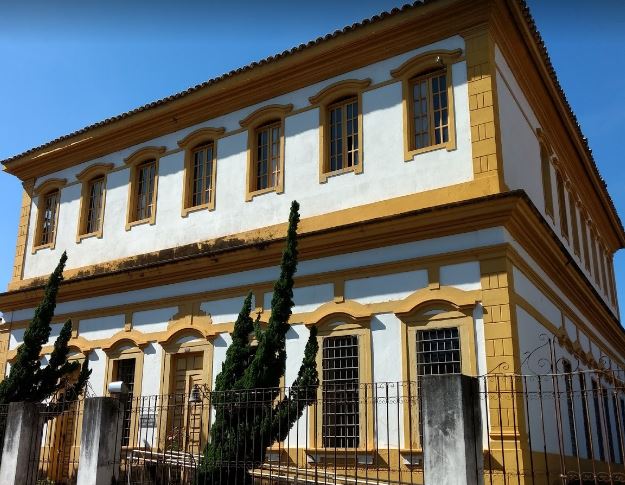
254;123;281;191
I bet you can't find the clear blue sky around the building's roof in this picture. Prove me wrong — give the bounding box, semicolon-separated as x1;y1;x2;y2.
0;0;625;314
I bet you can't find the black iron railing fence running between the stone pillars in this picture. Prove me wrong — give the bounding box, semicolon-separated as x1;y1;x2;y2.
13;364;625;485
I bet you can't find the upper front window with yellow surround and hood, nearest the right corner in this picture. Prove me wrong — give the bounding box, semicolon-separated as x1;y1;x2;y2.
391;49;462;160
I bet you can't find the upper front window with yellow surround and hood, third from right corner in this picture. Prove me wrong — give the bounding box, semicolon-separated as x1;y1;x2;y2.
239;104;293;201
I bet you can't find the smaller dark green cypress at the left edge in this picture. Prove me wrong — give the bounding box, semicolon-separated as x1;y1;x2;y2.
0;252;91;404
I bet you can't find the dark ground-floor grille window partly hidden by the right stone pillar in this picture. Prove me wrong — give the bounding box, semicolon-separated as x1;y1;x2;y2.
417;327;461;436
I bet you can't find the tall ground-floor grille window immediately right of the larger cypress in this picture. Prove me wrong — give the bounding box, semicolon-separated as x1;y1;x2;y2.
321;335;360;448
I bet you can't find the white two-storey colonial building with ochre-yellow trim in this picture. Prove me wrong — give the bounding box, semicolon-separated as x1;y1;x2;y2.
0;0;625;476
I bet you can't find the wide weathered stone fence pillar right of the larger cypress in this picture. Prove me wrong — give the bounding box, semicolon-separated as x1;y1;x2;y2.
421;374;484;485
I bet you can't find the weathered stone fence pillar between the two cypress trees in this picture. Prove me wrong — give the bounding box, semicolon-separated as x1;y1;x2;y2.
76;397;124;485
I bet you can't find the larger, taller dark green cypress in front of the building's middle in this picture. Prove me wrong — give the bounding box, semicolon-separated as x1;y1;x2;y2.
196;201;319;485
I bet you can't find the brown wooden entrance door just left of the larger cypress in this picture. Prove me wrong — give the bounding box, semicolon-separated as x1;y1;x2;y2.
168;352;207;454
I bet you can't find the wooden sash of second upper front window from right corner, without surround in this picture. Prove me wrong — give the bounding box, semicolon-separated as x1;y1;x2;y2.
328;98;360;172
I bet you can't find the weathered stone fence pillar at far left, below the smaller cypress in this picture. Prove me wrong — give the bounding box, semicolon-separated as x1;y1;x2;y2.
0;402;41;485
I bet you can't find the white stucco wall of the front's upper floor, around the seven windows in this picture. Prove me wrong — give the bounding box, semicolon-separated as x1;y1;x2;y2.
24;36;473;278
